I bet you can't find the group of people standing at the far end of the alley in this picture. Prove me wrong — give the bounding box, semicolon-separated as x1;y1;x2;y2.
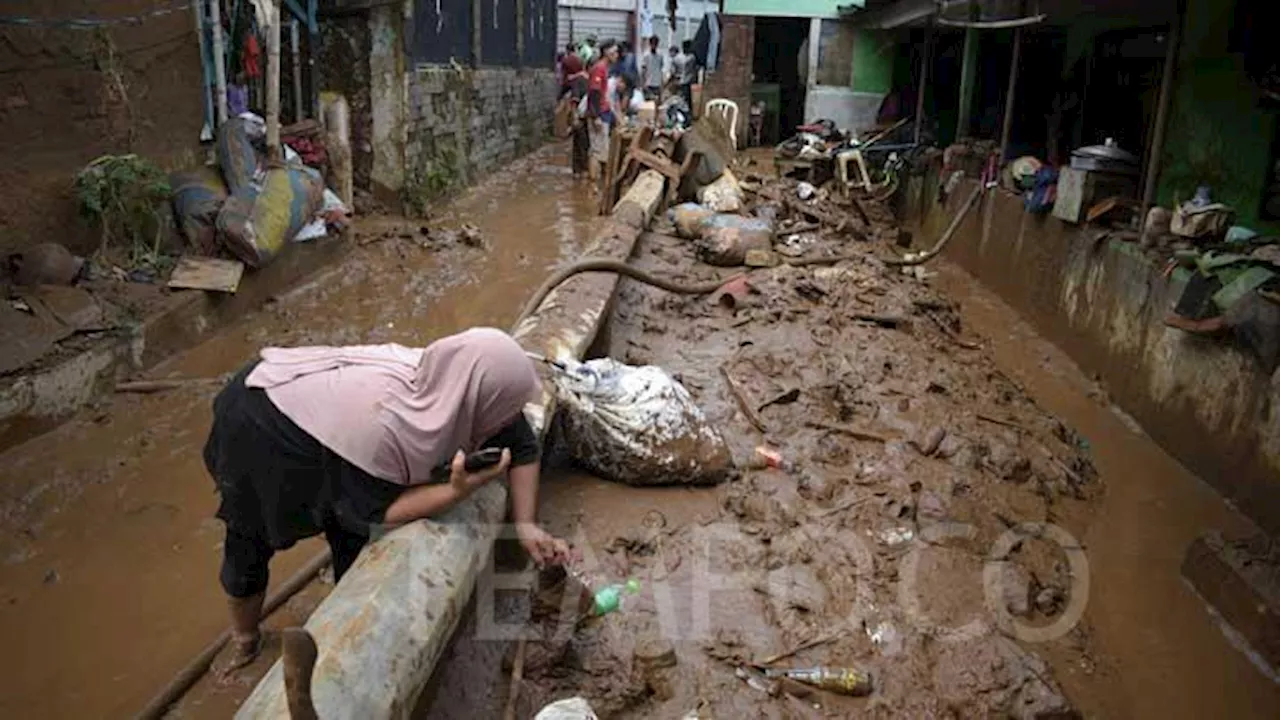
556;36;698;182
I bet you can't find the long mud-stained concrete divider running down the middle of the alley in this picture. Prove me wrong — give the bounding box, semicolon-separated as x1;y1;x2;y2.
236;170;664;719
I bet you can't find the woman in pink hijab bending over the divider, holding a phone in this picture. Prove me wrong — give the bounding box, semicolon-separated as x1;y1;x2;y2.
205;328;568;670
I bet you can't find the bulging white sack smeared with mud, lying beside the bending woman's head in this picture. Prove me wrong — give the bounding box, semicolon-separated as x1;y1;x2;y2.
552;357;733;486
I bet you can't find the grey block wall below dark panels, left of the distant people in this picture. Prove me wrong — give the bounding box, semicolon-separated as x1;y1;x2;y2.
404;67;556;190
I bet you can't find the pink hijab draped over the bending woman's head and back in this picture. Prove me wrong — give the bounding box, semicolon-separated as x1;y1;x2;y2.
244;328;539;484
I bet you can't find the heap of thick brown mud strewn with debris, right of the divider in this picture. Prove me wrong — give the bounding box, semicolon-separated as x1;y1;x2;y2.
509;173;1102;717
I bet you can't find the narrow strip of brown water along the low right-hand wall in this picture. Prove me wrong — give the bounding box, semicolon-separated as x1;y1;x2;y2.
940;264;1280;717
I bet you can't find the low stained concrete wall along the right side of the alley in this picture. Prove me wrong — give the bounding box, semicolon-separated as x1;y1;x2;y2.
904;170;1280;533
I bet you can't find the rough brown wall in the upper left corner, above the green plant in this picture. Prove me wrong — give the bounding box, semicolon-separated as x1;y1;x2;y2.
0;0;204;255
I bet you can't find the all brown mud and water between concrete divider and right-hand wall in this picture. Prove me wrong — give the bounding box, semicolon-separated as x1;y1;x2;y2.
417;176;1280;719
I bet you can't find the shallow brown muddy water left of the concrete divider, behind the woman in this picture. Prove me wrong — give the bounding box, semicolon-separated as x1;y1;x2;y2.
0;142;594;717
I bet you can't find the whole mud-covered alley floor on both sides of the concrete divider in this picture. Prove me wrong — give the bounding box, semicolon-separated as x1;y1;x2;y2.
0;145;1280;719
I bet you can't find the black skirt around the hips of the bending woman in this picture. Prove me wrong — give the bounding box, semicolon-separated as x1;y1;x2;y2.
205;363;406;550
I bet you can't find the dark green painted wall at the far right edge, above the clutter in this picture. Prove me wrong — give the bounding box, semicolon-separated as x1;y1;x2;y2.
1158;0;1280;226
